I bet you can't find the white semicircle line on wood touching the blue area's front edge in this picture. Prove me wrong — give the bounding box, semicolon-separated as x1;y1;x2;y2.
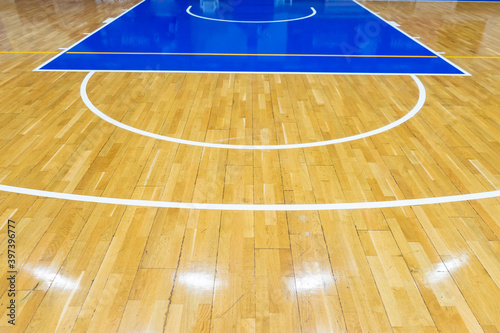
80;72;426;150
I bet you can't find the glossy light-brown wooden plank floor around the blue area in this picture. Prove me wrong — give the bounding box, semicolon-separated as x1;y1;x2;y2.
0;0;500;332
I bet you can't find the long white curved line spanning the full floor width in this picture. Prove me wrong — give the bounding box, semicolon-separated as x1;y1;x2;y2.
0;184;500;211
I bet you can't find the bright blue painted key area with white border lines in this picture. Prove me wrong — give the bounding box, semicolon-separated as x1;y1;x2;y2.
37;0;467;75
